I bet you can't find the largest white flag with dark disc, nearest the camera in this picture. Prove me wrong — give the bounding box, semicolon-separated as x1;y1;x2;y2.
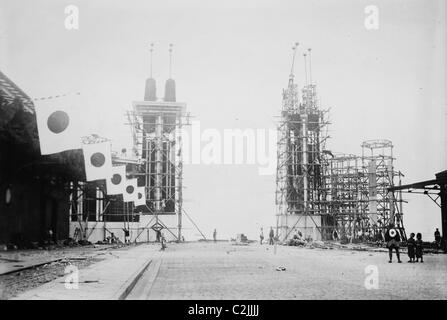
34;94;82;155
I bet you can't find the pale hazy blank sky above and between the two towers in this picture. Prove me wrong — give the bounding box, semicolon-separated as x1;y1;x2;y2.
0;0;447;239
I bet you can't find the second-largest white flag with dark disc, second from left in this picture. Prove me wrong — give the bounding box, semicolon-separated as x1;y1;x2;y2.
82;141;113;181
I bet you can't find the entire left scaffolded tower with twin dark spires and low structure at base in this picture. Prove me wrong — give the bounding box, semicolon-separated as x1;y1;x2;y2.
65;44;205;242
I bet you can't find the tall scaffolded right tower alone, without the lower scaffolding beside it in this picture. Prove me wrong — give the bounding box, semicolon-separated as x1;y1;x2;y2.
276;47;329;239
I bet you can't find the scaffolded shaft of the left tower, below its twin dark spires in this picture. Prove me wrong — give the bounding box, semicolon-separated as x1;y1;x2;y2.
127;101;187;239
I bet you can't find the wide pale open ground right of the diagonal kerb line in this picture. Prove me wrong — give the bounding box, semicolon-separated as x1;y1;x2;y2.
142;243;447;300
